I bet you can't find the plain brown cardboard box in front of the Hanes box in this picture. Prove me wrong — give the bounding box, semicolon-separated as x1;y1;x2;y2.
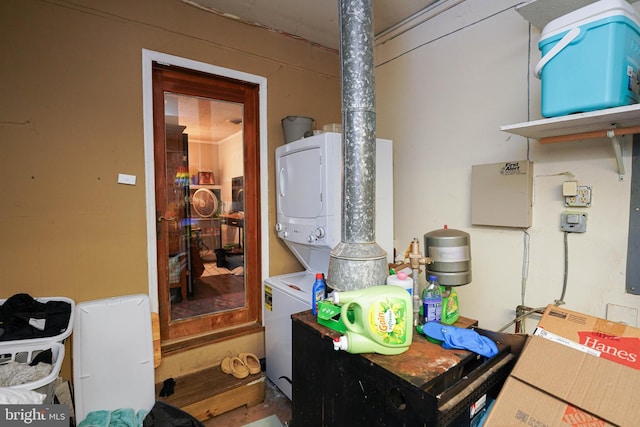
485;336;640;427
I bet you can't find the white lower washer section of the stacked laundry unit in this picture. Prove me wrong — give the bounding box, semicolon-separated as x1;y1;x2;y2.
263;271;316;399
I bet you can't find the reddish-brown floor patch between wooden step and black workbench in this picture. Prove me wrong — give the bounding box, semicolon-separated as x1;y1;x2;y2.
203;378;291;427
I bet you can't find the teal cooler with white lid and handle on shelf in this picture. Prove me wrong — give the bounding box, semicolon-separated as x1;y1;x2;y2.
535;0;640;117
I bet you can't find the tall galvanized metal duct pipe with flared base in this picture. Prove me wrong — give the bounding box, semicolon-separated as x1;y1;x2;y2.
327;0;391;291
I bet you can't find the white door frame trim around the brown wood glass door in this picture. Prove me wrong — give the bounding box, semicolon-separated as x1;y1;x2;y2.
142;49;269;342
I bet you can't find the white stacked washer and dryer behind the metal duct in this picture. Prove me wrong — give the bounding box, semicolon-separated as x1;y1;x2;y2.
263;132;393;399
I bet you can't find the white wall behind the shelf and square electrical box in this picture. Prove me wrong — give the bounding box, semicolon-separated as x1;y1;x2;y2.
375;0;640;332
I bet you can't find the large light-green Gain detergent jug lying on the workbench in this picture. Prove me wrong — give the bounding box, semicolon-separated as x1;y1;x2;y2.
333;285;413;354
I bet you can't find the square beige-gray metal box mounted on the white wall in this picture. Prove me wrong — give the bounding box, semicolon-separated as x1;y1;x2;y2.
471;160;533;228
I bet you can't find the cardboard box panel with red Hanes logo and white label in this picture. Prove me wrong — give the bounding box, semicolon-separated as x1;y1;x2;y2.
534;305;640;372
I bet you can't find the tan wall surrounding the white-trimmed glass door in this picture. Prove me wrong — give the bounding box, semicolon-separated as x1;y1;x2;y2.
0;0;341;380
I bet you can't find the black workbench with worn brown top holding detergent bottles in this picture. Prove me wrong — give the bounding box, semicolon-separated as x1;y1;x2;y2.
292;310;513;427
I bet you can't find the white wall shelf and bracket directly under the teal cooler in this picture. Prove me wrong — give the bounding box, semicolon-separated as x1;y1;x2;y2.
500;104;640;181
